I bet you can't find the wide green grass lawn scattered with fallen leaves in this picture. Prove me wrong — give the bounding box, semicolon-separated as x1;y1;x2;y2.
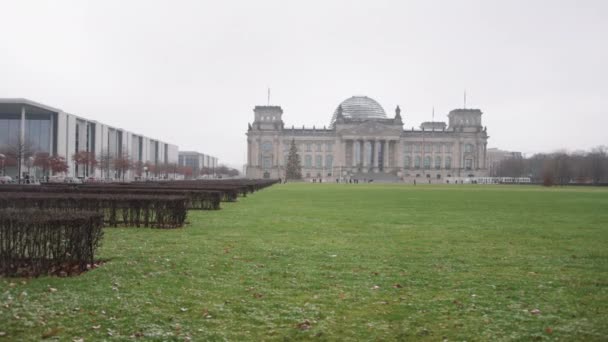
0;184;608;341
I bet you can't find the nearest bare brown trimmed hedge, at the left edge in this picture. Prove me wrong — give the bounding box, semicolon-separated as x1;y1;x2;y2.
0;209;103;276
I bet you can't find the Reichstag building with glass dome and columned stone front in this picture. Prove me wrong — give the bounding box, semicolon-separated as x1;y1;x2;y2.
247;96;488;182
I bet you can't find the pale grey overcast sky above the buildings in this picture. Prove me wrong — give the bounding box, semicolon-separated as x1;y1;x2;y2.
0;0;608;166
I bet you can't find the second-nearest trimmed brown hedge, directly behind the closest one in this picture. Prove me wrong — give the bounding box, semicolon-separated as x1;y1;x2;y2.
0;192;188;228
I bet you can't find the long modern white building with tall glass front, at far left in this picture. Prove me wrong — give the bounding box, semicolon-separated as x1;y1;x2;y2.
0;98;178;180
